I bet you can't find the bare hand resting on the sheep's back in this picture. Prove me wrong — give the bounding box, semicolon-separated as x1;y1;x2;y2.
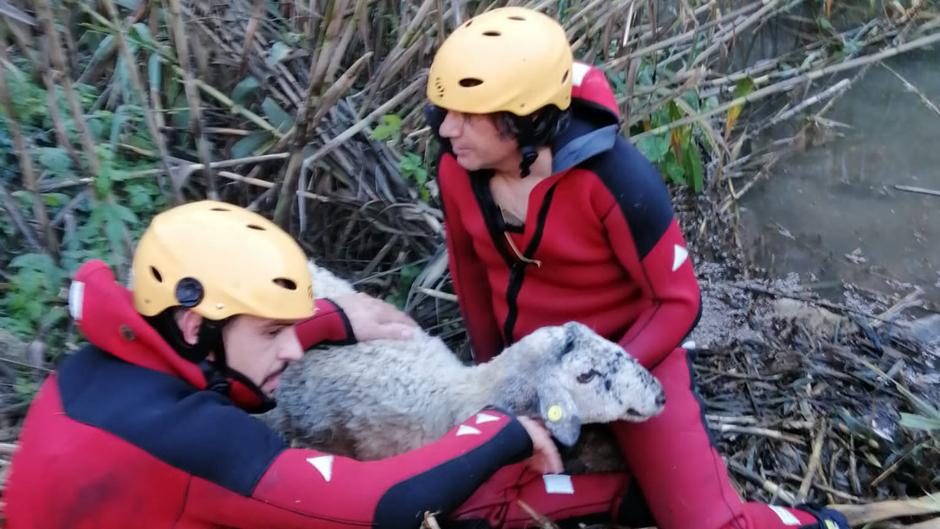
331;293;418;342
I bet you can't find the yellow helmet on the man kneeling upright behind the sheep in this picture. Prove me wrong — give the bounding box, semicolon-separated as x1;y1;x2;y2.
427;7;573;116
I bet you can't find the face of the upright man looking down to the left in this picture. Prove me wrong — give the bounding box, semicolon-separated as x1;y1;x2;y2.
438;110;519;171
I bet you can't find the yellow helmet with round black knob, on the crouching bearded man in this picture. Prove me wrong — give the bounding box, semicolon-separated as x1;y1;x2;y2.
131;200;314;320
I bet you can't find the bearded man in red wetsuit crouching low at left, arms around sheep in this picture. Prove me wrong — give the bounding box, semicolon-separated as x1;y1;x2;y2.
4;201;561;529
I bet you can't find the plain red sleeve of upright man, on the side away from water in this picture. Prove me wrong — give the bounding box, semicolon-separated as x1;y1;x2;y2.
438;155;502;362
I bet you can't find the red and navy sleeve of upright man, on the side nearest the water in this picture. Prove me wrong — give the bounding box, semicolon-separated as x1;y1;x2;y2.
603;140;701;367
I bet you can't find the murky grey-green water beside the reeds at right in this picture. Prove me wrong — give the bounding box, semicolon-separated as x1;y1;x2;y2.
742;47;940;307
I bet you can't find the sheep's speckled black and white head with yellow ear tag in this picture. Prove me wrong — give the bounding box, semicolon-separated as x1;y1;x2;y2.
518;322;666;446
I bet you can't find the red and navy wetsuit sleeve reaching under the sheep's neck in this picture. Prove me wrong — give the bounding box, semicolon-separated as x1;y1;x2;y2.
187;410;532;529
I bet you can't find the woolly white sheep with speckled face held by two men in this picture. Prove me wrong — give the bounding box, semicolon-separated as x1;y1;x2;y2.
267;265;665;460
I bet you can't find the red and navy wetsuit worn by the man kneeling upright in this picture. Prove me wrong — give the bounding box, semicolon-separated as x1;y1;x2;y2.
438;64;837;529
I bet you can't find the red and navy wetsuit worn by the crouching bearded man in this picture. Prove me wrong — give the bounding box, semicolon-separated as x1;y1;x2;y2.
5;262;544;529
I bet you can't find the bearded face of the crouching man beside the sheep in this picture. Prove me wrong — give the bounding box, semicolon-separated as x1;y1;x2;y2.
222;316;304;397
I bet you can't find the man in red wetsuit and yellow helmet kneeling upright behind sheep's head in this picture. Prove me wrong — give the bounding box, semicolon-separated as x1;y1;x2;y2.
427;7;848;529
